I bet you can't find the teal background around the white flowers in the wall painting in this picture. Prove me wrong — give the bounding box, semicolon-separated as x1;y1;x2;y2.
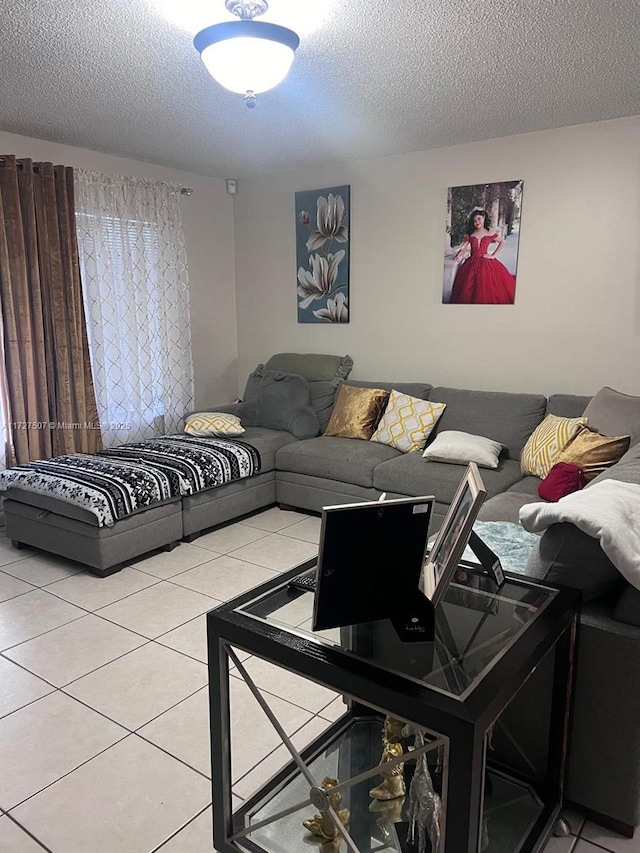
295;184;351;324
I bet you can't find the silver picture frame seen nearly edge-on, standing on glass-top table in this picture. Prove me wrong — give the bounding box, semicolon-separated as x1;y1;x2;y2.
420;462;487;607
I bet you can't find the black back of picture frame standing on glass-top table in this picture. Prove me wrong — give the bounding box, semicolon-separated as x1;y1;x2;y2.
313;497;434;631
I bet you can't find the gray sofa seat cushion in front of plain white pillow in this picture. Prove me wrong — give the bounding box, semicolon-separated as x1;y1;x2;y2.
373;456;522;504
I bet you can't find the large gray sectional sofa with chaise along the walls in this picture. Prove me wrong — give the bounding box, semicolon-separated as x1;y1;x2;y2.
5;354;640;834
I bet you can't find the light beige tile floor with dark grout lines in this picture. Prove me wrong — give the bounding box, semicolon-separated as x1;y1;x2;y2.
0;508;640;853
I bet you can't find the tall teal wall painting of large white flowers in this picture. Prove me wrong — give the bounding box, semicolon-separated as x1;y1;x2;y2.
296;185;350;323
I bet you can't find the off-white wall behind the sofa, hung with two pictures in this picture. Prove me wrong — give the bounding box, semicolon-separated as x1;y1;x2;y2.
235;117;640;394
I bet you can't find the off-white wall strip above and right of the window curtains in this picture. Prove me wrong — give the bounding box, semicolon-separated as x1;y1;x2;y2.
0;132;238;406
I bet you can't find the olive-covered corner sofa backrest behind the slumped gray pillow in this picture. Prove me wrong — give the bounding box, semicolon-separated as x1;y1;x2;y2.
242;352;353;433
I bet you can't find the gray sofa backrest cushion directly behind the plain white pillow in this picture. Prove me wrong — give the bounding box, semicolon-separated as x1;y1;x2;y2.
429;386;547;459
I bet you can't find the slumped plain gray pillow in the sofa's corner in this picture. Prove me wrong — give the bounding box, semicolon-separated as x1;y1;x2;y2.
236;370;320;439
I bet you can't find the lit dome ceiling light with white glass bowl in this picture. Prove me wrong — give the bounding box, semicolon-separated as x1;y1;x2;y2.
193;0;300;109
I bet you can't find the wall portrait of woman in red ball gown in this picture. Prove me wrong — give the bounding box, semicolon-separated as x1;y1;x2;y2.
442;181;523;305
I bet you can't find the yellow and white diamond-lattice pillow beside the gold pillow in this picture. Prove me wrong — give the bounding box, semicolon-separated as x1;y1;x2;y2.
371;391;446;453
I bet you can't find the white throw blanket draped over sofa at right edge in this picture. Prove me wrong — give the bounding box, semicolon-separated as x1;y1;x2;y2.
520;480;640;589
